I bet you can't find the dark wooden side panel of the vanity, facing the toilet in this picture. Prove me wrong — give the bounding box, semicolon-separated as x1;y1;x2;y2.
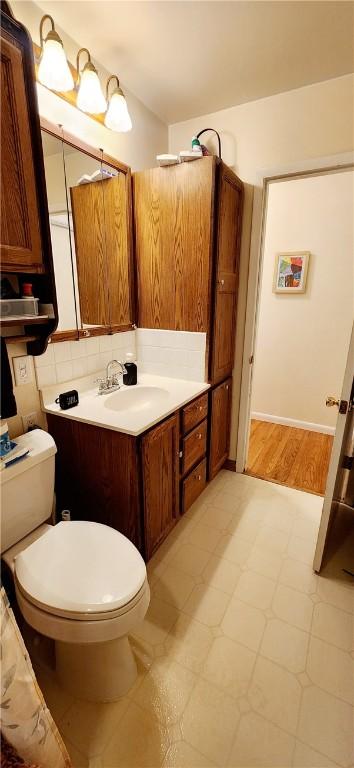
47;414;144;551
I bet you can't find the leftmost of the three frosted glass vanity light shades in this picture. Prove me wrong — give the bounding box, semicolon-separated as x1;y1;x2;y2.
38;14;74;92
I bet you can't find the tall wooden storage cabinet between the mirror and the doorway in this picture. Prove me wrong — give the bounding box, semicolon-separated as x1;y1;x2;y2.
133;157;243;477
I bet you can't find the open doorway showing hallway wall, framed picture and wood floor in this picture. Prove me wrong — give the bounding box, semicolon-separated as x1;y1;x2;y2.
244;166;354;495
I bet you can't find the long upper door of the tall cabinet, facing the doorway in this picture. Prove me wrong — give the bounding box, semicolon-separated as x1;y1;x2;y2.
210;163;243;383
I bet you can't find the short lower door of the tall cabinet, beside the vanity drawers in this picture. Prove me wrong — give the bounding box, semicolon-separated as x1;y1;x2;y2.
209;379;232;480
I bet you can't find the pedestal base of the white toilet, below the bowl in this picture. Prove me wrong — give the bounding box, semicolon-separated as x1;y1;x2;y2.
55;635;138;702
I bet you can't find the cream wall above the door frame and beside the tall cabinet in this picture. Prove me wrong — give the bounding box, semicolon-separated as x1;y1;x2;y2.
169;75;354;459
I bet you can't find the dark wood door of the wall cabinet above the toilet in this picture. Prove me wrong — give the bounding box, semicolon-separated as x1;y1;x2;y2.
1;27;43;272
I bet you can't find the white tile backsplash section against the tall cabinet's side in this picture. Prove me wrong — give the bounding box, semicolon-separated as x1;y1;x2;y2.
136;328;206;381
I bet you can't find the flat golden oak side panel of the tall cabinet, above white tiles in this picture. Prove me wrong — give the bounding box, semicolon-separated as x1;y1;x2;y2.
133;157;215;332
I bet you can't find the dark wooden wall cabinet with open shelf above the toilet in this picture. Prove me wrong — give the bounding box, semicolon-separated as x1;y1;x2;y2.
0;2;57;354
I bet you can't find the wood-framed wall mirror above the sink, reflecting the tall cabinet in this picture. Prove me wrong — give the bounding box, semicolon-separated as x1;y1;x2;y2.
41;120;134;341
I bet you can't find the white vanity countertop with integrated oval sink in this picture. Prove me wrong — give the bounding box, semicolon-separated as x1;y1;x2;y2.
42;373;210;437
